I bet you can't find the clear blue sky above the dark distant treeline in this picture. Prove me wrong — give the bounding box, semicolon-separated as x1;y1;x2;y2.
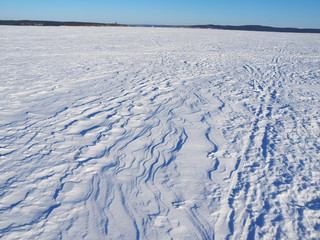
0;0;320;28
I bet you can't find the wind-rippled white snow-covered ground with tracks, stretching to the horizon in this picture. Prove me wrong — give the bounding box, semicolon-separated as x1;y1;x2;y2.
0;26;320;240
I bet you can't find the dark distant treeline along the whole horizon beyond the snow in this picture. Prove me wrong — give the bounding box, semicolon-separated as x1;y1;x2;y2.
0;20;320;33
